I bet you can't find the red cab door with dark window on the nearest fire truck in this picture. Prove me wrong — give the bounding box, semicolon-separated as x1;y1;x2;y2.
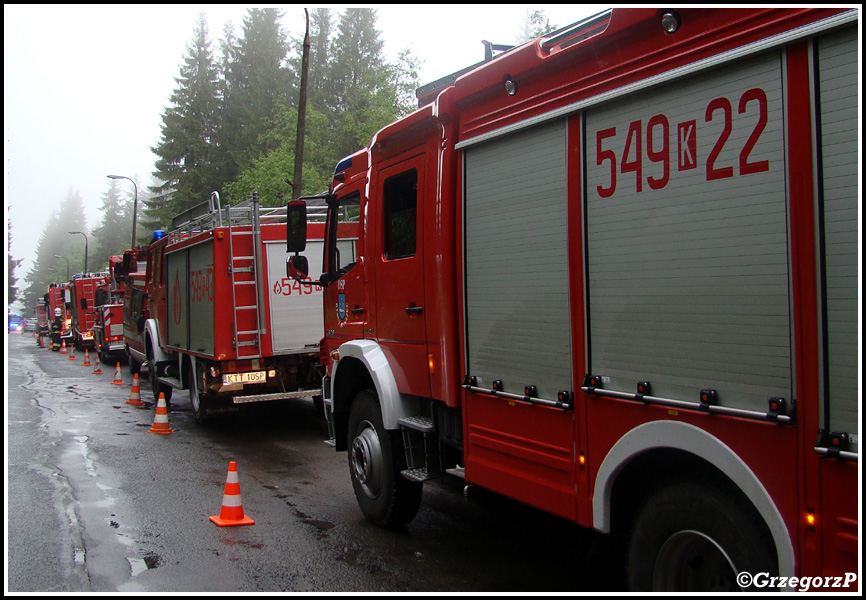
373;155;430;397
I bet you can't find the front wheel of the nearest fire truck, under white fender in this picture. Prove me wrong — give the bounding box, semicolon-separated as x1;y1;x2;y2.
347;390;422;528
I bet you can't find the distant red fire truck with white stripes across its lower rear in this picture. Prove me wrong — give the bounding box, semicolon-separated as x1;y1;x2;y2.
93;256;126;364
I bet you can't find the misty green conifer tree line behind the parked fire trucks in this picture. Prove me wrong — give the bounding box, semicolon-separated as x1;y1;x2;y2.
16;8;418;312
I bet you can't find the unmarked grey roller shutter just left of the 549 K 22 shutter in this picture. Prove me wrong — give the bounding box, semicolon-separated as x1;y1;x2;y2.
465;122;572;399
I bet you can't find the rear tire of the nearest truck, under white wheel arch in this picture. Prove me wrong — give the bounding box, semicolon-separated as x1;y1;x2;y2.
627;481;778;592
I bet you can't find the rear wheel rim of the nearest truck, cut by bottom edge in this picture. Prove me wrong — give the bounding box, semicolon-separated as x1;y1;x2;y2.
653;530;740;592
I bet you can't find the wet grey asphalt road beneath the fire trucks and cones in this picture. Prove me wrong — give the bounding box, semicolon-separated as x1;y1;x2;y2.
6;333;624;593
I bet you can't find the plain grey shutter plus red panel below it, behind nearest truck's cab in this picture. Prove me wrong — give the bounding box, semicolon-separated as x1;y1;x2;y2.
463;120;580;519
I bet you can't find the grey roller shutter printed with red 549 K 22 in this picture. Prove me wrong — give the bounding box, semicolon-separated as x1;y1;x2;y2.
586;53;792;411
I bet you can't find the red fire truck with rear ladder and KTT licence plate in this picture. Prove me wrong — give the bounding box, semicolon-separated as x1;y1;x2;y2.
142;193;338;421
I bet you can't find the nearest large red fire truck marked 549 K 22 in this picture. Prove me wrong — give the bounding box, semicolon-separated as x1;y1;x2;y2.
287;8;860;591
